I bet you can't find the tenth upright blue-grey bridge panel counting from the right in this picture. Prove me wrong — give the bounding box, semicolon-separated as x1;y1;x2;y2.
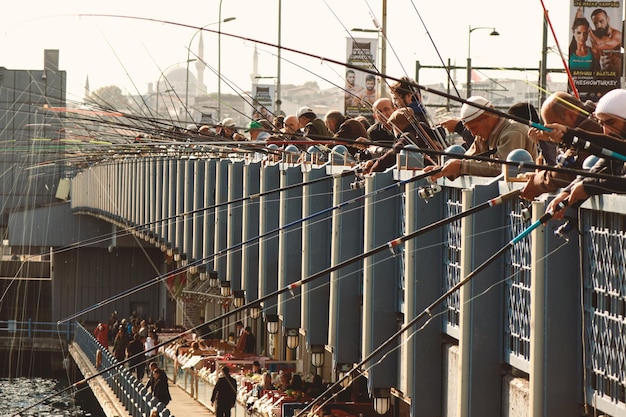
226;162;244;290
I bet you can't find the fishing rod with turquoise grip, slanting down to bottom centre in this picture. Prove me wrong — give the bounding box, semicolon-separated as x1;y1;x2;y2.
294;192;567;417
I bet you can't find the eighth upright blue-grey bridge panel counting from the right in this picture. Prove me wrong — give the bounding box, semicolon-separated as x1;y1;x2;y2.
259;165;280;314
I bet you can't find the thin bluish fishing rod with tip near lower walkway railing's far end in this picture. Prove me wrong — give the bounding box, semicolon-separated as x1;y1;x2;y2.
57;168;441;324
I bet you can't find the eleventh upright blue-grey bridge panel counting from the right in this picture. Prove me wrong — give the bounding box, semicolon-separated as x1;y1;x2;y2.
213;159;231;280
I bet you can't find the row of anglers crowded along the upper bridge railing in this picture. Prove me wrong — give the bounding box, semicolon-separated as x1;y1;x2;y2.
178;70;626;224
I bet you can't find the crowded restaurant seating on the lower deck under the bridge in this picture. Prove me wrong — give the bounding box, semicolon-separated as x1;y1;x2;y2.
159;334;410;417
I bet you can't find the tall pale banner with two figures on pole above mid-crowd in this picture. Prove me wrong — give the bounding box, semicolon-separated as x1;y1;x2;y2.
344;38;379;123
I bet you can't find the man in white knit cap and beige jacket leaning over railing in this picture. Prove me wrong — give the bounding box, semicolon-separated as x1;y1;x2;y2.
424;96;537;180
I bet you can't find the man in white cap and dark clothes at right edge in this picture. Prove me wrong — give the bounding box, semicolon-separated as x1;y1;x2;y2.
544;89;626;220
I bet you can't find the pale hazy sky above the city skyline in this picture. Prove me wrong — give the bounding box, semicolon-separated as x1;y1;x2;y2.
0;0;570;100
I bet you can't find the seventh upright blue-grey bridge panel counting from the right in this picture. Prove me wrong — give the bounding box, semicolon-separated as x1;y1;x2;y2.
278;166;302;329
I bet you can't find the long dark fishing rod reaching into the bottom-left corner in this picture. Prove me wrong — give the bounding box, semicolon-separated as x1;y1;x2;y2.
13;184;516;417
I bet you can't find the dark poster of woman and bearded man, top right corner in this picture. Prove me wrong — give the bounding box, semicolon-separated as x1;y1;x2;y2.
569;0;624;102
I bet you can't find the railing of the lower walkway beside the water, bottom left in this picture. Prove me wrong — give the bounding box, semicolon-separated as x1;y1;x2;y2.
74;324;173;417
